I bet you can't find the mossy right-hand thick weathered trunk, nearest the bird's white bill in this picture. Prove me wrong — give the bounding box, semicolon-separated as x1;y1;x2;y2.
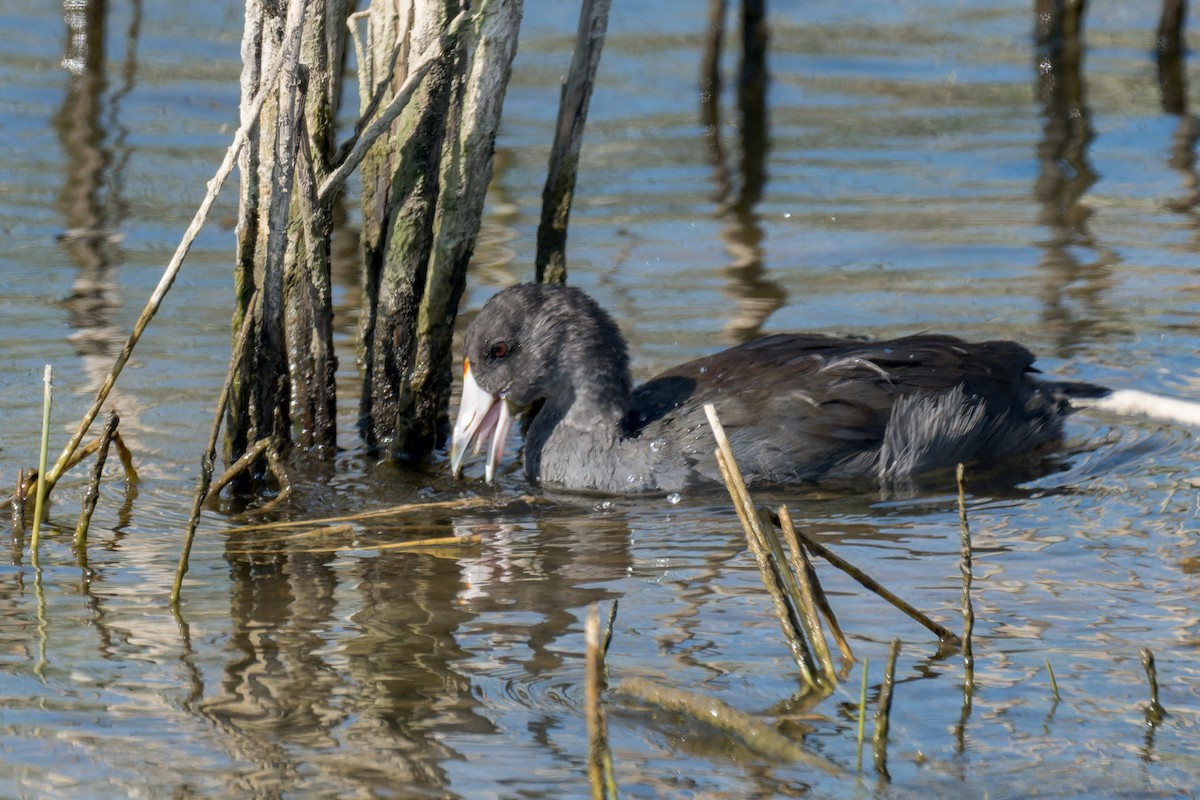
360;0;523;458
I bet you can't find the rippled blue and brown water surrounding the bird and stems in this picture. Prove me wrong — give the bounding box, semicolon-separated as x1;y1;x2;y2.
0;0;1200;798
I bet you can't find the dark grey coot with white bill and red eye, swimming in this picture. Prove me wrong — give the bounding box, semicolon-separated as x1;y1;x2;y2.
450;284;1200;494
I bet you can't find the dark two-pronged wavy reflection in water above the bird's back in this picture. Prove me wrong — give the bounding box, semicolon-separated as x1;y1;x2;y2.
700;0;786;342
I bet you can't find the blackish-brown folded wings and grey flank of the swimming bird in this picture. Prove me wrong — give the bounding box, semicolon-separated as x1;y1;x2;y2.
629;335;1066;483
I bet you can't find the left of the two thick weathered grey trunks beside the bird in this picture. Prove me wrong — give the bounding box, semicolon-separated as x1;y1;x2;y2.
226;0;348;474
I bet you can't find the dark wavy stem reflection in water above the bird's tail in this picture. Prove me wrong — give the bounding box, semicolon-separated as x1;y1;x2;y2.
1034;0;1120;355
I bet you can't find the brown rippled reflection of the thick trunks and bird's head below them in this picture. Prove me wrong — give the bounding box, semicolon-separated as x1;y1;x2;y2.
188;501;632;796
